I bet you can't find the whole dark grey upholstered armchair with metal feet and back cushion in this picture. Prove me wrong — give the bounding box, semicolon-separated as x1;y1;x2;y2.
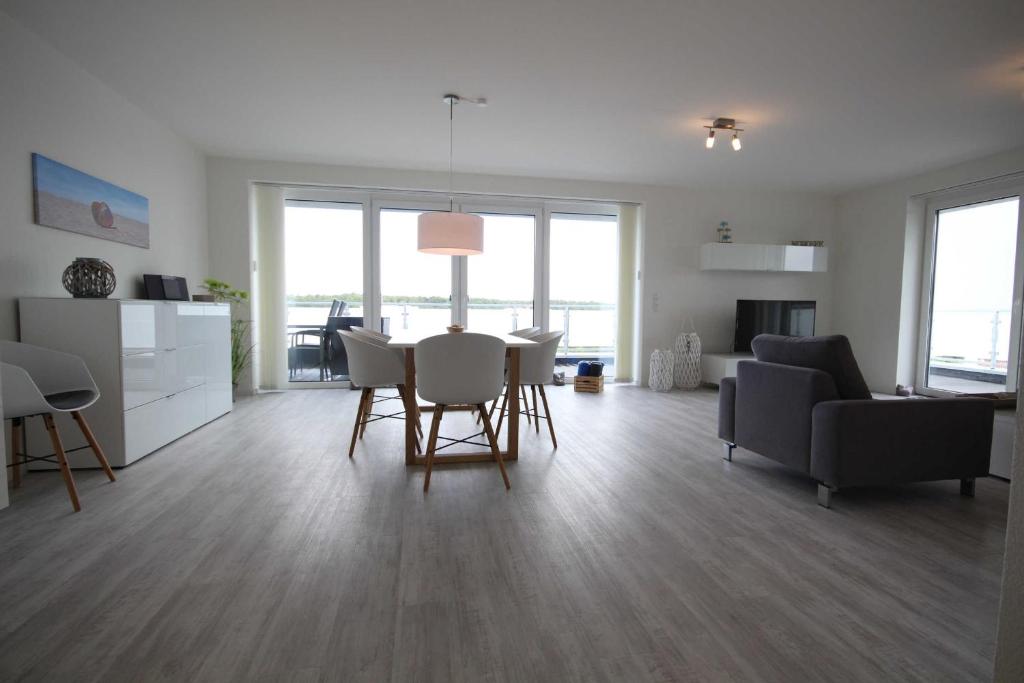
718;335;992;508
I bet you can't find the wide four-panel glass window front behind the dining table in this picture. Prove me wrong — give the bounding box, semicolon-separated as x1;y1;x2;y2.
276;187;620;386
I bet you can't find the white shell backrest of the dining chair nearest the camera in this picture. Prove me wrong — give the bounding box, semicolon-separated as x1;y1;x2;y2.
416;332;505;405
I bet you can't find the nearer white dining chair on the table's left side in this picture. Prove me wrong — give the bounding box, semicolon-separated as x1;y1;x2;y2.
338;330;423;458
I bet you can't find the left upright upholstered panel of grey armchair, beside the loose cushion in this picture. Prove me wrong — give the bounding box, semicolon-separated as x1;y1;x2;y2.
735;360;839;472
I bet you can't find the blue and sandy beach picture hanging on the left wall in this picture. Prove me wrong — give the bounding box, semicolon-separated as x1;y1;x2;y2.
32;154;150;249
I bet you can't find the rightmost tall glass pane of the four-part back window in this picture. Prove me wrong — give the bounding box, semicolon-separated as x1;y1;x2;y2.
548;213;618;376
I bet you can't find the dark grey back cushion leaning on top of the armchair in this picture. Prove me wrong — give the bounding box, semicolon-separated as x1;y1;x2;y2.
751;335;871;399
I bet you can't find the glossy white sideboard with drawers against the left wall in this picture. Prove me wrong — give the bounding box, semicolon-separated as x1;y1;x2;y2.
18;299;231;467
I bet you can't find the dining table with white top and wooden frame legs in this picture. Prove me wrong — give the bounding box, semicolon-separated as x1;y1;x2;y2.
387;330;537;465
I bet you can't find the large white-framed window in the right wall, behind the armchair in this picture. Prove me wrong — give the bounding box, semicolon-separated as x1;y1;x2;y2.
919;195;1021;394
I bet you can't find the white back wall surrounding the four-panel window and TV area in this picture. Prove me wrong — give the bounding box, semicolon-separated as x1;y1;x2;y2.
207;158;836;389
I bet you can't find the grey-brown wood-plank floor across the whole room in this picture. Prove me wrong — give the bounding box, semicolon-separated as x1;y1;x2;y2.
0;387;1008;683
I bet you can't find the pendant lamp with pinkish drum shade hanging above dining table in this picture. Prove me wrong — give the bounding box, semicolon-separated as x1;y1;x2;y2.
416;93;487;256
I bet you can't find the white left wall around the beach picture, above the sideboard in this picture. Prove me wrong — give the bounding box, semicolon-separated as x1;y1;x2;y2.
0;12;208;339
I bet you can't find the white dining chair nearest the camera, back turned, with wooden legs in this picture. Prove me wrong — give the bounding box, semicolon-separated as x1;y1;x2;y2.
416;333;512;493
